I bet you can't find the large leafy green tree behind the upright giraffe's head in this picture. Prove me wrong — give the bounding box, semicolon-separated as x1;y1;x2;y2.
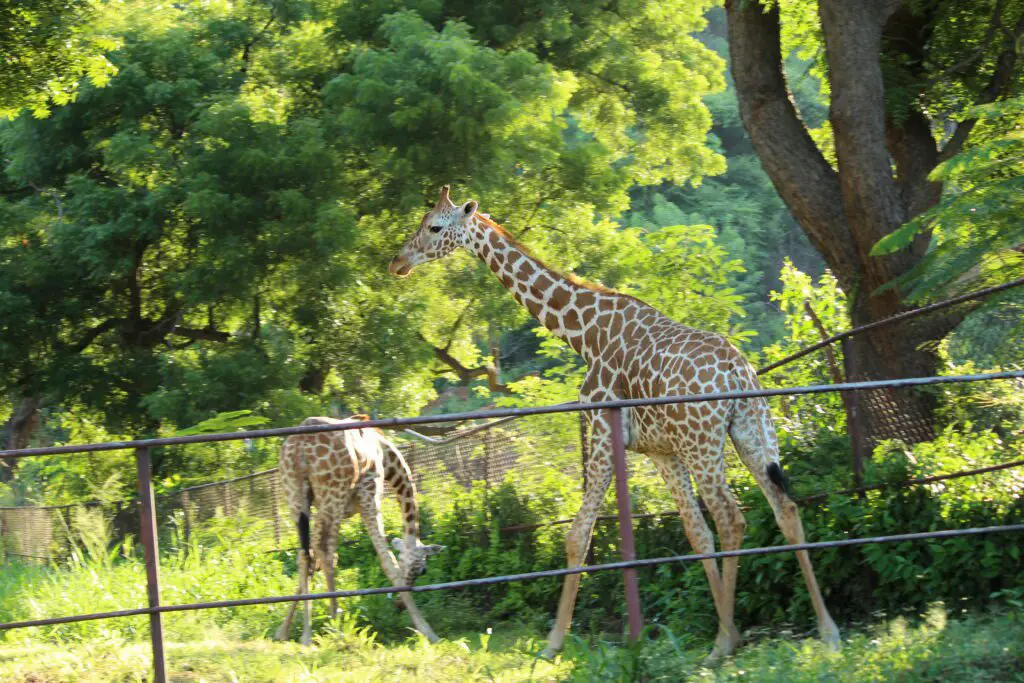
0;0;723;485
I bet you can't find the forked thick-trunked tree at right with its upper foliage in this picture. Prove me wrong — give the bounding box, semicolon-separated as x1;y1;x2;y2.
726;0;1024;438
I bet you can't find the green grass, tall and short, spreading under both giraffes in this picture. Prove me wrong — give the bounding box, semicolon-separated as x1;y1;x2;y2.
0;509;1024;683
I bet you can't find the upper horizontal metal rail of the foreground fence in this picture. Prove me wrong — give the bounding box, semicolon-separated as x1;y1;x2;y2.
0;370;1024;458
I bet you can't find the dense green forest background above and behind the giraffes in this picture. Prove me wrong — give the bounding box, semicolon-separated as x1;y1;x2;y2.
0;0;1024;503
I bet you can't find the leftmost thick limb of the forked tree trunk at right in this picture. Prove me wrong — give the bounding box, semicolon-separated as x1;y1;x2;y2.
725;0;858;288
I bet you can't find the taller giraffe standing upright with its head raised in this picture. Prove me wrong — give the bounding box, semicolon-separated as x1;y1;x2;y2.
389;185;840;659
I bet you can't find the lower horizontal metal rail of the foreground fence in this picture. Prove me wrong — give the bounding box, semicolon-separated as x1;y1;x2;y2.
0;524;1024;631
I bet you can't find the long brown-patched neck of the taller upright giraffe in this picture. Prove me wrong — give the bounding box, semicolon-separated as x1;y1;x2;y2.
466;214;618;360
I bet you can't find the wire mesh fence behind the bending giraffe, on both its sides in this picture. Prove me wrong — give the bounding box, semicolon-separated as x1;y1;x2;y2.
0;414;593;562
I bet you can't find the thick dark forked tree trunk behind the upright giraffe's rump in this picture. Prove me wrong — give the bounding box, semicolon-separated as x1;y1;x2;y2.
726;0;959;441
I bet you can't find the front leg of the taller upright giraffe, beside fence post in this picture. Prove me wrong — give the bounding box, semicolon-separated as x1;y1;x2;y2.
543;413;613;657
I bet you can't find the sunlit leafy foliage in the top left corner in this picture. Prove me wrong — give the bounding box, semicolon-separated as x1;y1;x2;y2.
0;0;117;118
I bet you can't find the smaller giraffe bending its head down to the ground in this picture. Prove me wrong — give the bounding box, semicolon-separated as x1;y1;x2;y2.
275;415;444;645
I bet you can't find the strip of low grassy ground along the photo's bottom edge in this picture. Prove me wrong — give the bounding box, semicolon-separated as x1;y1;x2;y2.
0;607;1024;683
